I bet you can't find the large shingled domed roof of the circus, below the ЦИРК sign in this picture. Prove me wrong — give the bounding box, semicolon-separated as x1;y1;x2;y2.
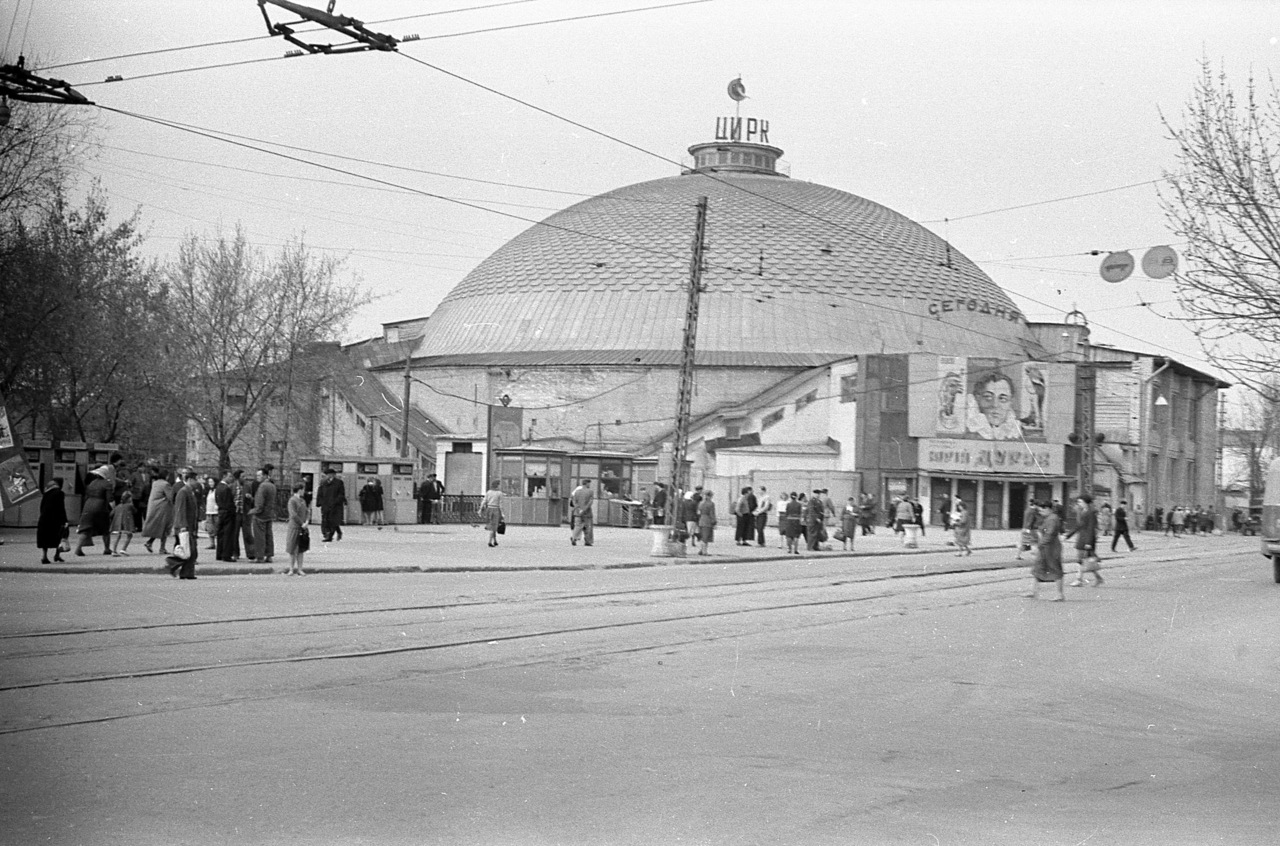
415;153;1034;366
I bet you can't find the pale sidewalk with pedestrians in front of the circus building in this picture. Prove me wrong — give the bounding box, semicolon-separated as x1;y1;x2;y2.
0;523;1254;576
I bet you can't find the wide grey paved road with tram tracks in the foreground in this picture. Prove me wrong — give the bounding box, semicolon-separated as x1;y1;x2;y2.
0;538;1280;845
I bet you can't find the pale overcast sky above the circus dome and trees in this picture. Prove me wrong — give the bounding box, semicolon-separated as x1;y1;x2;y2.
12;0;1280;383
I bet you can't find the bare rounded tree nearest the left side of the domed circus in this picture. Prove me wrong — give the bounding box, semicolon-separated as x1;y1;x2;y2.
159;229;371;468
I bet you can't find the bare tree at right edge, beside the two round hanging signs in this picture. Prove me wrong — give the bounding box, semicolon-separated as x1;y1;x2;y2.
1161;63;1280;399
